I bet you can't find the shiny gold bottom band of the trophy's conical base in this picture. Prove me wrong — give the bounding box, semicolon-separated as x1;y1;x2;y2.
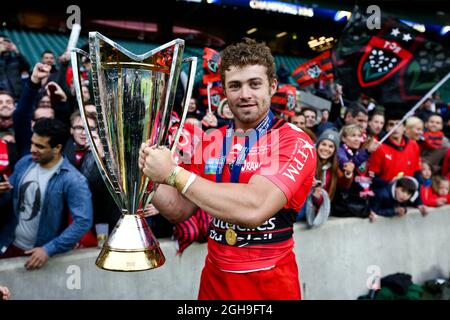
95;244;166;272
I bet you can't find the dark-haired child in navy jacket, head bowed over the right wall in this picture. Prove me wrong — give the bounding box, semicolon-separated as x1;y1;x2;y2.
370;176;419;222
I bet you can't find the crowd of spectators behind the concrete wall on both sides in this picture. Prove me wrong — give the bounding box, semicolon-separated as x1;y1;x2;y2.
0;31;450;269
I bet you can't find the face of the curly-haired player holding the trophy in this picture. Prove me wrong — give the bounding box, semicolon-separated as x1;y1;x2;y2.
225;65;277;130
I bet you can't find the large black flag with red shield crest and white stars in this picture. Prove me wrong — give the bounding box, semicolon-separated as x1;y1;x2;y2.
332;7;450;113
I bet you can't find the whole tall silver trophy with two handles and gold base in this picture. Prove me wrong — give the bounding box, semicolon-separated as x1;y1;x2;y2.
71;32;197;271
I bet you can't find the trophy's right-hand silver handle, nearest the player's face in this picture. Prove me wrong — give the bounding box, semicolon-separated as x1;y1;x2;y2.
142;57;197;209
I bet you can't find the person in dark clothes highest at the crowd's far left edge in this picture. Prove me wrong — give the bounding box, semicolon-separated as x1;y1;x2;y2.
0;35;30;100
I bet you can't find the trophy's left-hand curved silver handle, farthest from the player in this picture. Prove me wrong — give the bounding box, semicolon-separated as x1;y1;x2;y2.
70;48;123;208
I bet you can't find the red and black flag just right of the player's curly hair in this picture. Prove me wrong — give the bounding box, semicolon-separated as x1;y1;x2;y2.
292;50;333;88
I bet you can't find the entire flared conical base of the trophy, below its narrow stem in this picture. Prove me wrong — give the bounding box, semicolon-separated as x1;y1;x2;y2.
95;214;166;271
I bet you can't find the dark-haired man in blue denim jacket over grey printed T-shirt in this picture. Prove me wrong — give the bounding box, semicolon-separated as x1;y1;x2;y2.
0;119;92;270
